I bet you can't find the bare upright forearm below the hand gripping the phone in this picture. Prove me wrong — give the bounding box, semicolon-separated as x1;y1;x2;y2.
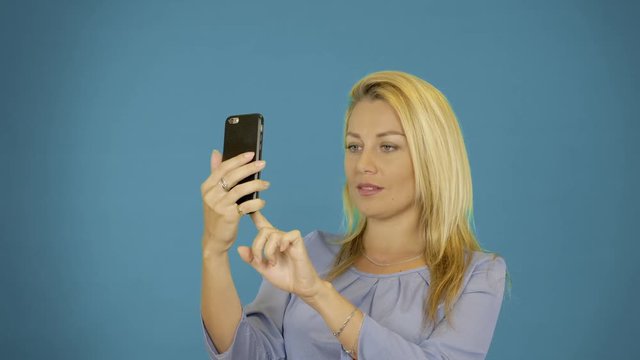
201;245;242;353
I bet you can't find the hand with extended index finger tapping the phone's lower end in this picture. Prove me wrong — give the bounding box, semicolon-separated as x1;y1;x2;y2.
238;211;323;300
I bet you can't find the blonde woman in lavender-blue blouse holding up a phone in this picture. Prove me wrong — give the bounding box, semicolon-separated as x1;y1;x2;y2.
201;71;506;360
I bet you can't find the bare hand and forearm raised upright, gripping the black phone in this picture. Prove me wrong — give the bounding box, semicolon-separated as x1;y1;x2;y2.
200;151;269;351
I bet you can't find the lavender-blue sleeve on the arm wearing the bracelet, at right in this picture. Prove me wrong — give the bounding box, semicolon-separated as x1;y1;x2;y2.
358;257;506;360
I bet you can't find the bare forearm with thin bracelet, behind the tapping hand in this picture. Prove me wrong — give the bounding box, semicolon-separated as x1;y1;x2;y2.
305;281;364;358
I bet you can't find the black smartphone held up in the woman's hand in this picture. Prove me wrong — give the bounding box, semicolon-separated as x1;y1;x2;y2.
222;114;264;205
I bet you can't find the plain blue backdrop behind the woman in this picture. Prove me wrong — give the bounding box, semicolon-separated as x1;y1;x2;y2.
0;0;640;359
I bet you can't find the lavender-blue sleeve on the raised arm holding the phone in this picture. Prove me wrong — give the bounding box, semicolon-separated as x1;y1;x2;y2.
202;280;290;360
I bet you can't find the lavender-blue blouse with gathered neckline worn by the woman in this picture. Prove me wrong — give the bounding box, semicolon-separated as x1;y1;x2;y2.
202;231;506;360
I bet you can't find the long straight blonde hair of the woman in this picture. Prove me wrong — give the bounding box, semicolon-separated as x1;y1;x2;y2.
327;71;481;323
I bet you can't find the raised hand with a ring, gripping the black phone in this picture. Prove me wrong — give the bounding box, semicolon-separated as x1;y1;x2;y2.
200;150;269;256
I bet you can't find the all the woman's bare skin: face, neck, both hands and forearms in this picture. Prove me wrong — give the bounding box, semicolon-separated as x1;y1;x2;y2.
201;100;423;358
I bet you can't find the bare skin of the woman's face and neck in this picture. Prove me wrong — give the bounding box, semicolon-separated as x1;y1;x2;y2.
344;100;424;273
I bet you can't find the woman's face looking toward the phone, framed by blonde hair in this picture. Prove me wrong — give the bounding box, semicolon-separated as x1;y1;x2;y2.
344;100;415;219
